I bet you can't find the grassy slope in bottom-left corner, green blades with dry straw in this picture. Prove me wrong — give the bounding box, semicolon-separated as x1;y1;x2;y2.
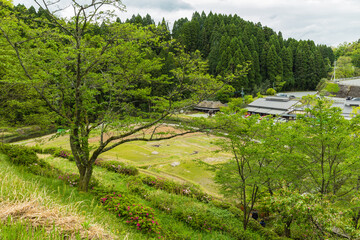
0;154;144;240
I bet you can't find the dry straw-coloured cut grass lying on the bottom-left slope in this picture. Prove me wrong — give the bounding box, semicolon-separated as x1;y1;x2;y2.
0;201;114;239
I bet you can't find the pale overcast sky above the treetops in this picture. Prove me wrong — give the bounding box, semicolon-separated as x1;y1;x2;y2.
13;0;360;46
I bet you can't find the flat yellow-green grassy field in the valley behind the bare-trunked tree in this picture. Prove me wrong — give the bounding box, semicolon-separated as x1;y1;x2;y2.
18;127;231;197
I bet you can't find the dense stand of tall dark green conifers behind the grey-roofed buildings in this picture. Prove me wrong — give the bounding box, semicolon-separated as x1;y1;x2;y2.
127;12;335;94
